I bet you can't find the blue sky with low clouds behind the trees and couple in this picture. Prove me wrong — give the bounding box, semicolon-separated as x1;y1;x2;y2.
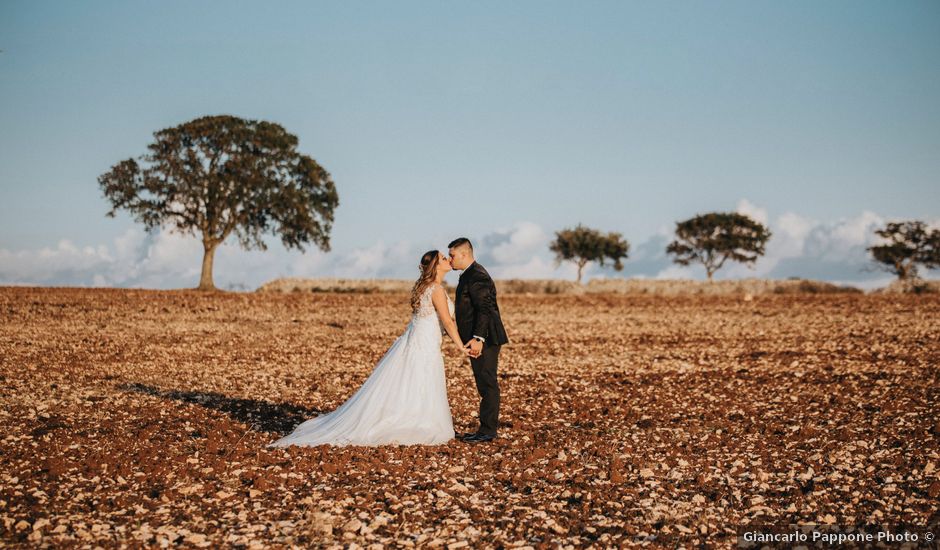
0;1;940;288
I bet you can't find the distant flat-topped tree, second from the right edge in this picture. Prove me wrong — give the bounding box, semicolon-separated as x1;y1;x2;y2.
666;212;771;281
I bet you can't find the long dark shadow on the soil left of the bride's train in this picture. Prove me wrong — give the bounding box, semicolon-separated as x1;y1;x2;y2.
118;382;323;435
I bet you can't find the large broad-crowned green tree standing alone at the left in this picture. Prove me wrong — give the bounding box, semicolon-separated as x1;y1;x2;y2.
98;115;339;290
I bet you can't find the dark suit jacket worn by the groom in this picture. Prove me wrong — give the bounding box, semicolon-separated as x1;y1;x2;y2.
454;262;509;346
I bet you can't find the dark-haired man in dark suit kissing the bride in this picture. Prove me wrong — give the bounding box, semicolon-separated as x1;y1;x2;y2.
447;237;509;443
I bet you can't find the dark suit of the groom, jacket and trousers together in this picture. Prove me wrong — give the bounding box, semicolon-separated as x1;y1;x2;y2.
454;262;509;435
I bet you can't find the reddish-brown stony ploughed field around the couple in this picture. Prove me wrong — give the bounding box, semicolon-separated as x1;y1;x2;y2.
0;287;940;549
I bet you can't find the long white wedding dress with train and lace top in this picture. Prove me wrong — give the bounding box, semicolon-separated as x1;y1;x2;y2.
268;284;454;447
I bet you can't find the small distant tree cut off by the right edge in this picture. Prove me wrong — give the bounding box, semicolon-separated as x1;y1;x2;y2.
866;221;940;281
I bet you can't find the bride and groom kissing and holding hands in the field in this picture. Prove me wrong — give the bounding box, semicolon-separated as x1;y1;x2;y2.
268;237;509;447
